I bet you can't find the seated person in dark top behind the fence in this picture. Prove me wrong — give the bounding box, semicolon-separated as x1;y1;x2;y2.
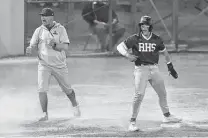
82;1;125;52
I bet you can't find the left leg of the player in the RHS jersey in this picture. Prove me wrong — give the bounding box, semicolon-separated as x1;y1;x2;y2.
129;66;149;131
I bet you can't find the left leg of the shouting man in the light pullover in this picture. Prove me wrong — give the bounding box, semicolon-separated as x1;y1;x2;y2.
38;67;51;121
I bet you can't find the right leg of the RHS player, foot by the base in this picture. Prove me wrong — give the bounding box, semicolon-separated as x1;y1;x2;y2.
150;66;181;122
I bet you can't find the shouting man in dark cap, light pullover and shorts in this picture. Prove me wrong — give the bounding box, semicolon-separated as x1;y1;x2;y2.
26;8;80;121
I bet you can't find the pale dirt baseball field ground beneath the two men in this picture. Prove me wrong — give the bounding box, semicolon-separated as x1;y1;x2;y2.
0;53;208;137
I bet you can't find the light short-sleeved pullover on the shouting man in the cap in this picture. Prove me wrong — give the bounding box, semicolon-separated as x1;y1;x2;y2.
30;22;70;68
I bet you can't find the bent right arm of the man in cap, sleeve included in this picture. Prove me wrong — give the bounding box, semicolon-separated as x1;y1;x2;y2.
53;27;70;52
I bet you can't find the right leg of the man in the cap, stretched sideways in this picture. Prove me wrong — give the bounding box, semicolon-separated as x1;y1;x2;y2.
52;68;81;117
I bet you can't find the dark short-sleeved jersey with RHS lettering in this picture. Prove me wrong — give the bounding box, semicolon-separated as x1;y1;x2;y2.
124;33;165;65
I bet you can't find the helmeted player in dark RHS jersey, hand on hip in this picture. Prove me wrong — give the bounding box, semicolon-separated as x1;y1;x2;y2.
117;16;181;131
